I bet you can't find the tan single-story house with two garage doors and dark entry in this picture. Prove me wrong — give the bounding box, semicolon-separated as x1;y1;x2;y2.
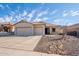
14;20;62;36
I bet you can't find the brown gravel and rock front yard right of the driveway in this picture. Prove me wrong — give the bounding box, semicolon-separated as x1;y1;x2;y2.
34;35;79;56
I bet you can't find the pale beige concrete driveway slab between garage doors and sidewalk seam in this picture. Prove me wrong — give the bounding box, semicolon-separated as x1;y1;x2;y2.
0;36;42;51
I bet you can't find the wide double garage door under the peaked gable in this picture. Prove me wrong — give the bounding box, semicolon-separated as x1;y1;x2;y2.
16;28;32;36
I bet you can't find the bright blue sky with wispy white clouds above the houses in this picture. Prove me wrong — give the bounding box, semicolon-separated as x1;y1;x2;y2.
0;3;79;25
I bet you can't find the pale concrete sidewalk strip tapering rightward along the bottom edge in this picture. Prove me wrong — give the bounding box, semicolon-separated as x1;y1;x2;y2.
0;48;59;56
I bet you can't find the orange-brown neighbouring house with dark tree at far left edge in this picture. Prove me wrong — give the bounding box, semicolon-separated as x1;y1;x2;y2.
0;22;15;36
